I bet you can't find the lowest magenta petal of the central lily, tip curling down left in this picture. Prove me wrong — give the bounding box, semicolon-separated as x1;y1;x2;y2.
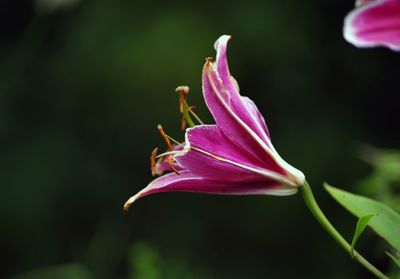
124;171;297;210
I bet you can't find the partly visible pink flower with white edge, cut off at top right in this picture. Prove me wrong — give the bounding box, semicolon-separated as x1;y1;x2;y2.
343;0;400;51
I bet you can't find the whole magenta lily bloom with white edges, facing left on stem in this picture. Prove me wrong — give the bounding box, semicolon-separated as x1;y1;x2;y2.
124;35;305;209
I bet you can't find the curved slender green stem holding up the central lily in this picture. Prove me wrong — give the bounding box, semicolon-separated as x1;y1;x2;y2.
300;181;388;279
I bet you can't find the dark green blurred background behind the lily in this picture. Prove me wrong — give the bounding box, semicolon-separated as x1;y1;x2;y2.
0;0;400;279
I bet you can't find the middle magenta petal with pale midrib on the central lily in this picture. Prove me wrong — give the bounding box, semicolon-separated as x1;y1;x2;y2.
175;125;290;184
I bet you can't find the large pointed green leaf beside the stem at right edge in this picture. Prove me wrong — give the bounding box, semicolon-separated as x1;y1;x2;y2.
324;183;400;251
